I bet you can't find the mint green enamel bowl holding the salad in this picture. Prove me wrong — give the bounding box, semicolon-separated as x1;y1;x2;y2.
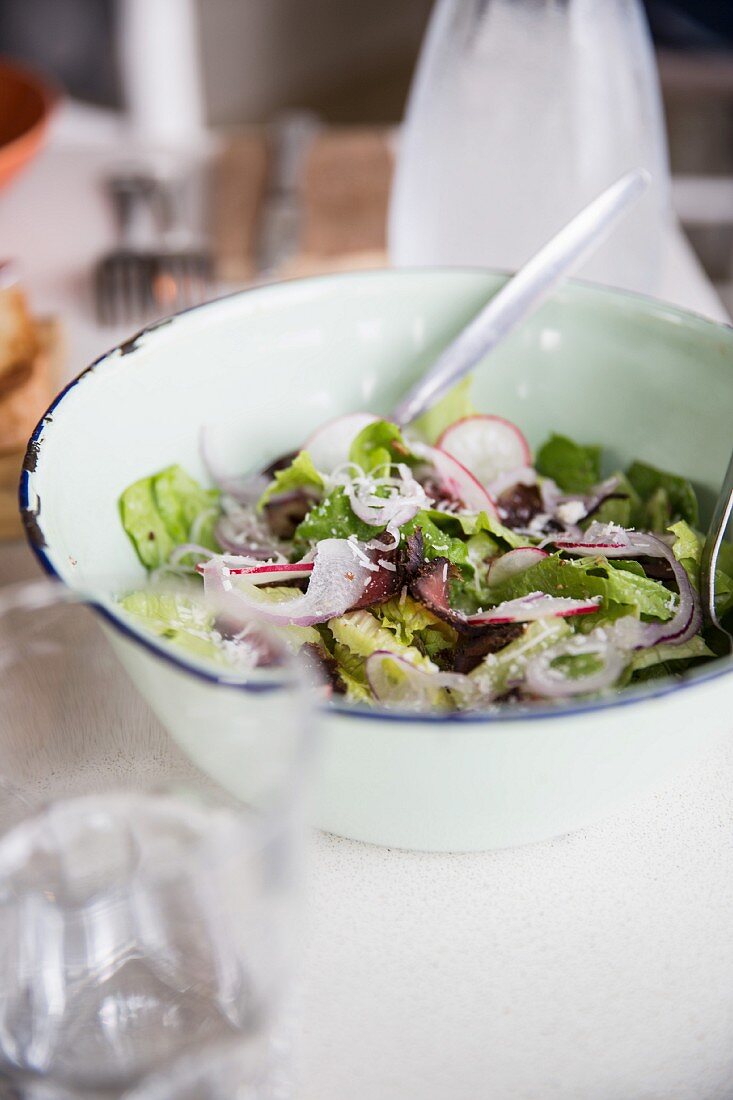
21;271;733;850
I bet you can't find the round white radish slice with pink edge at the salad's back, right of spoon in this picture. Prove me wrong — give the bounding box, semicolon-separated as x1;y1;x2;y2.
437;414;532;485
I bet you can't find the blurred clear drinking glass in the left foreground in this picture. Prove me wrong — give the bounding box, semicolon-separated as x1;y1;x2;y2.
0;582;310;1100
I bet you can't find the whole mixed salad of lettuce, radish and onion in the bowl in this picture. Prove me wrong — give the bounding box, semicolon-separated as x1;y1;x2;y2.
120;383;733;711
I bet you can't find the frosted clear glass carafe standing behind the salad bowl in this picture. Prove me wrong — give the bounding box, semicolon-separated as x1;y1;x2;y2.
389;0;669;292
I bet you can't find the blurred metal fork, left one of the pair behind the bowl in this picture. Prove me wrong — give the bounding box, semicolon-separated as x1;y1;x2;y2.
95;173;155;325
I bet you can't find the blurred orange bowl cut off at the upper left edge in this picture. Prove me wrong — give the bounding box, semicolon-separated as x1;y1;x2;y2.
0;61;57;187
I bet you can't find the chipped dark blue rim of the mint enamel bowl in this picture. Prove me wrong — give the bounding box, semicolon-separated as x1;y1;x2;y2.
18;266;733;726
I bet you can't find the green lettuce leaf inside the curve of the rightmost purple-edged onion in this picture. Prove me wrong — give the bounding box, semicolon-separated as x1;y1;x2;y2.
491;554;675;629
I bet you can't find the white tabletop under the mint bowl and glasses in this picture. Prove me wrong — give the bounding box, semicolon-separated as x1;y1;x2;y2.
0;105;733;1100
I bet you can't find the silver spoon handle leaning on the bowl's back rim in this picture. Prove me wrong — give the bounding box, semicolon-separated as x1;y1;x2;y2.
393;168;649;426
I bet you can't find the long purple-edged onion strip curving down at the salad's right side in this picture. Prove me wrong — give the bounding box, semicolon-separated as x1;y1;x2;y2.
551;524;702;649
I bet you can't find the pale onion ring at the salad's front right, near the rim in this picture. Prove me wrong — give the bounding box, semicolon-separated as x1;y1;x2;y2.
524;627;628;699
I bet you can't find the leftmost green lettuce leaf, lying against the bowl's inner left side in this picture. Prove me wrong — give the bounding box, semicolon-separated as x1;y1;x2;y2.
120;465;219;569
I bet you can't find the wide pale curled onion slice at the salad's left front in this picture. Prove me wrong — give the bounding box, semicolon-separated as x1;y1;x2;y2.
204;539;371;626
